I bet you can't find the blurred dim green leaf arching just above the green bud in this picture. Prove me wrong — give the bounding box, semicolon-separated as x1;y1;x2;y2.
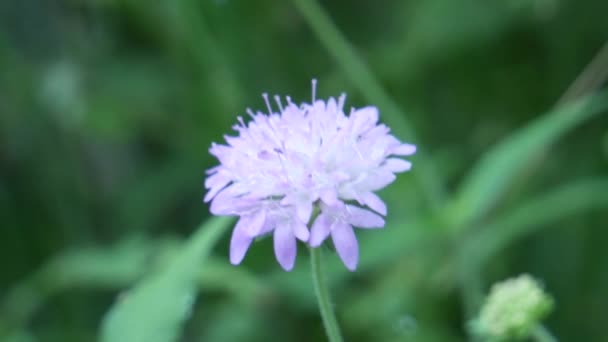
463;178;608;266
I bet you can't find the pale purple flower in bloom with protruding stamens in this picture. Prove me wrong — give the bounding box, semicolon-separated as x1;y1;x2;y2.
205;80;416;271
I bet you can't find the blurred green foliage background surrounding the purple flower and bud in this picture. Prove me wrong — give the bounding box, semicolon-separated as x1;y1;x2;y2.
0;0;608;342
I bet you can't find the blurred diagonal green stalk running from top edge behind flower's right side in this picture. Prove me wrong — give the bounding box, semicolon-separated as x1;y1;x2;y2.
293;0;445;208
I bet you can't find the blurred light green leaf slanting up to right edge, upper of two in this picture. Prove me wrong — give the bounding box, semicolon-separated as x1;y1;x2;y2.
448;92;608;228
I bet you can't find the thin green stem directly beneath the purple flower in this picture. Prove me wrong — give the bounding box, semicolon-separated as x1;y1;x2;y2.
310;248;342;342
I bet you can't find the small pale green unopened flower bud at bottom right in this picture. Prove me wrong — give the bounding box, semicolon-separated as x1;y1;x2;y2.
471;274;553;340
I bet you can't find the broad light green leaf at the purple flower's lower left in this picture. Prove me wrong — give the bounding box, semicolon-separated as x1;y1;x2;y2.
101;217;231;342
